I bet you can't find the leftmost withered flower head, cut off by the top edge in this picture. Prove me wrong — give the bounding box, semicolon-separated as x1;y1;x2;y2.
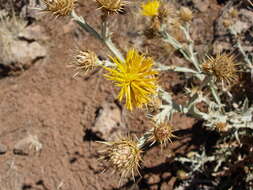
42;0;77;16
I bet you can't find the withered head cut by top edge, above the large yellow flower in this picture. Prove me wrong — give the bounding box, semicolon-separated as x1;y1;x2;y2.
96;0;127;14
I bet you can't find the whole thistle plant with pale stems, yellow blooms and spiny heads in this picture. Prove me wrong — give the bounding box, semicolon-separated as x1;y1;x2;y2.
36;0;253;187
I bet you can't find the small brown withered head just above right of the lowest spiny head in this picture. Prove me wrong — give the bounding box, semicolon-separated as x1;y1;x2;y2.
149;122;176;145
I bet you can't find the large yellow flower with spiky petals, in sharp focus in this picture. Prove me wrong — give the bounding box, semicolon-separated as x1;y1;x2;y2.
105;49;157;110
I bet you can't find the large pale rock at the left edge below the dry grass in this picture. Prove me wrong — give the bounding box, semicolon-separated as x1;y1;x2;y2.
0;21;47;76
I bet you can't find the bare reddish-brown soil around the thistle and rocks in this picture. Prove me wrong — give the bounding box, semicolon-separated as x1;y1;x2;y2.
0;1;222;190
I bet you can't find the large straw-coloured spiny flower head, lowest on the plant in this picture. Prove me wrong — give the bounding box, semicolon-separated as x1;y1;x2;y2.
100;137;142;177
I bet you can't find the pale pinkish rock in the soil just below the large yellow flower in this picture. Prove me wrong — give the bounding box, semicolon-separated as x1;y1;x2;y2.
92;102;125;139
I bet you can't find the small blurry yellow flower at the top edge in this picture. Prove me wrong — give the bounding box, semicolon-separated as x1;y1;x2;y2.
141;0;160;16
